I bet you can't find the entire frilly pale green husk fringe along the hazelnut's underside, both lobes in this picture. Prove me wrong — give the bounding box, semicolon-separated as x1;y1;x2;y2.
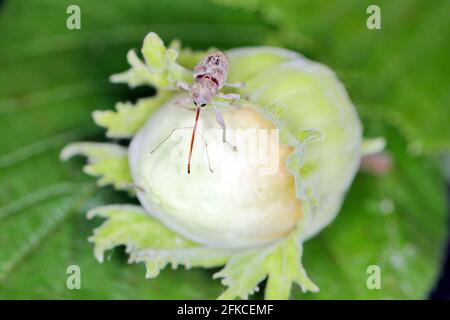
88;201;318;299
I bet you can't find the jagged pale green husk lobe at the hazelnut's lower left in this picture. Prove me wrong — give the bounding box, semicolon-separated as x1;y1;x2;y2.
88;205;231;278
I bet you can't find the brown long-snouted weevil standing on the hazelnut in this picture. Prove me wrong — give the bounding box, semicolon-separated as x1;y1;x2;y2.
152;51;246;174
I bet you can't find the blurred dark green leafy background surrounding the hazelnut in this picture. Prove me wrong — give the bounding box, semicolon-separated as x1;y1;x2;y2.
0;0;450;299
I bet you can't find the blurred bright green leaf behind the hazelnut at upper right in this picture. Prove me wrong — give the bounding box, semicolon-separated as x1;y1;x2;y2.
213;0;450;153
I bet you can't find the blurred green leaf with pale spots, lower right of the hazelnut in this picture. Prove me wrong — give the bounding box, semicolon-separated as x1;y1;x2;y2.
295;123;448;299
